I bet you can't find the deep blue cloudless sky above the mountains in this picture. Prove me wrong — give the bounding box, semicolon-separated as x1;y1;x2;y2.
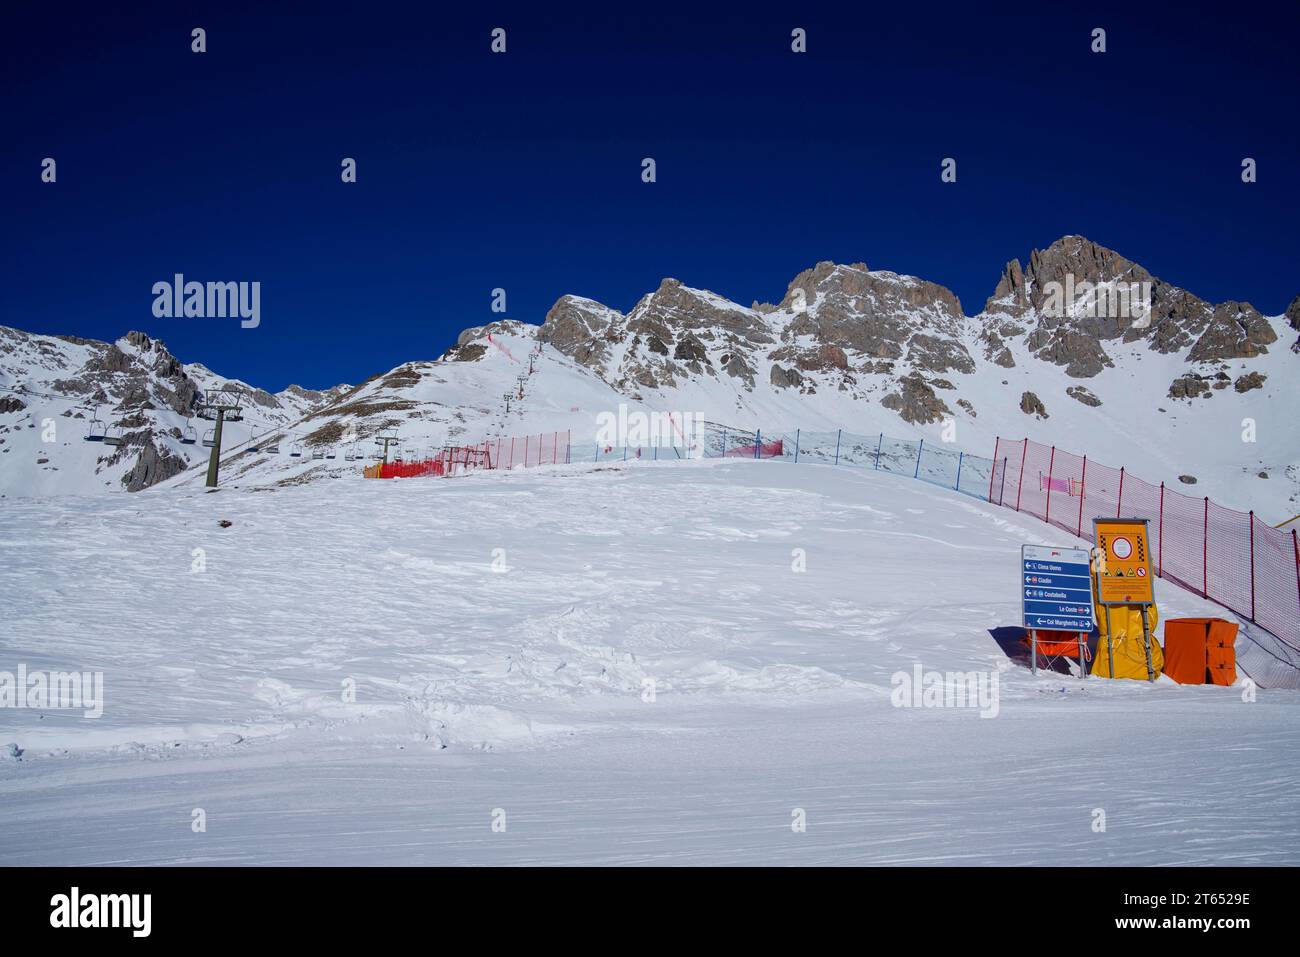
0;0;1300;389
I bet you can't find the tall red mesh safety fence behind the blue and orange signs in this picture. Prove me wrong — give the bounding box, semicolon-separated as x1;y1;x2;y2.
988;438;1300;668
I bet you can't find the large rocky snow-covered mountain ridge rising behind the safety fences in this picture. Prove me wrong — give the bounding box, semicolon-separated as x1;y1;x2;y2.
0;237;1300;520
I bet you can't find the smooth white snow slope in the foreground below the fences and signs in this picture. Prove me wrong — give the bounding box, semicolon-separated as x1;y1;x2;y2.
0;459;1300;865
